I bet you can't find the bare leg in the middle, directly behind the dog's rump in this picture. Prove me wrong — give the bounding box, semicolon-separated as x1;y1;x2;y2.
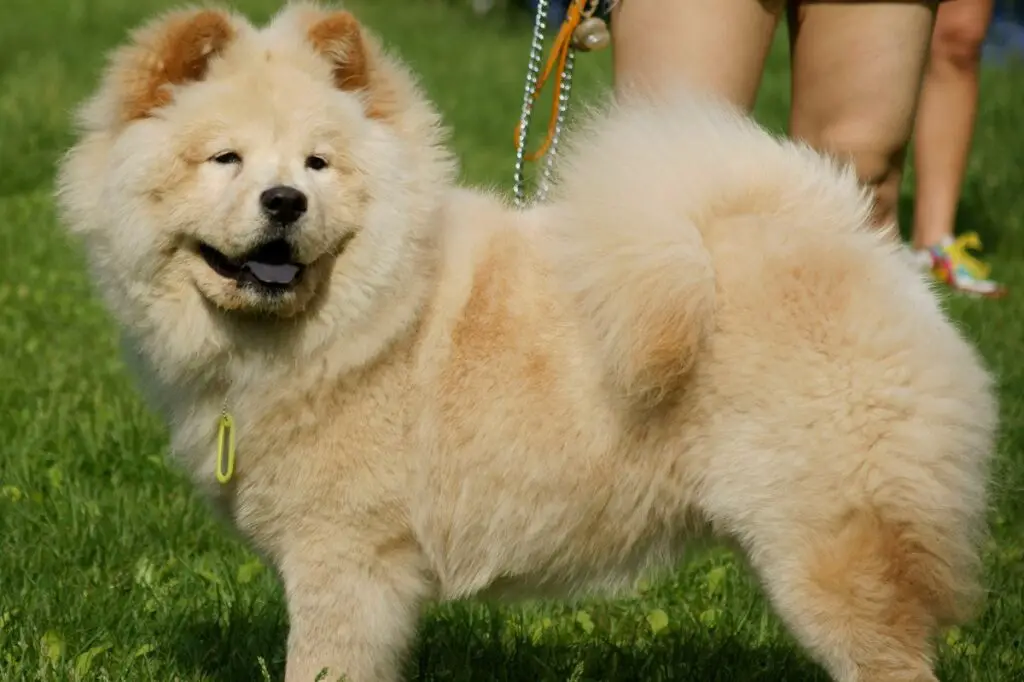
788;0;935;237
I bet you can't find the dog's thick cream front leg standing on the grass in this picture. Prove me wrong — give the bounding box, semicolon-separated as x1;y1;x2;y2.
282;538;428;682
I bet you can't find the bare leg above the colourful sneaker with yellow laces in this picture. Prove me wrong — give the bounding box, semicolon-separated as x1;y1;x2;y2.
913;0;993;249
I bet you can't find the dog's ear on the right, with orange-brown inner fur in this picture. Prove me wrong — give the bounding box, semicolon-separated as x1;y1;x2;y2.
306;11;394;119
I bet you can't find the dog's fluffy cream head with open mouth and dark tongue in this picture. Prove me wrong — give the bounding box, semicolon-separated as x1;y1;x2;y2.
58;4;453;372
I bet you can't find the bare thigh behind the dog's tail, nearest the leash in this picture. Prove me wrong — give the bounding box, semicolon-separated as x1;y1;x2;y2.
611;0;782;111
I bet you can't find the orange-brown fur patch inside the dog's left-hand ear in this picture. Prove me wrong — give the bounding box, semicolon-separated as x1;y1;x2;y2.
122;9;234;121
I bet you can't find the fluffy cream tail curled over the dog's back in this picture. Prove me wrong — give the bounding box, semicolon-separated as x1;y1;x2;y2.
540;87;870;409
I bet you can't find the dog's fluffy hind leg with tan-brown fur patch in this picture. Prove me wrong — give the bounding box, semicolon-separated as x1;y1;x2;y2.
708;456;979;682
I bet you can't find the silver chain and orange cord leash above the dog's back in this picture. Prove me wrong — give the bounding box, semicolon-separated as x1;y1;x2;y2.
513;0;611;208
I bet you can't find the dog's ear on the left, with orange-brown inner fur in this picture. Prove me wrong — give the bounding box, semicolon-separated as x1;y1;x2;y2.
108;9;237;123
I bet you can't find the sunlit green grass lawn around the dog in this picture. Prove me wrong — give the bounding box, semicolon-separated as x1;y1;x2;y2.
0;0;1024;682
